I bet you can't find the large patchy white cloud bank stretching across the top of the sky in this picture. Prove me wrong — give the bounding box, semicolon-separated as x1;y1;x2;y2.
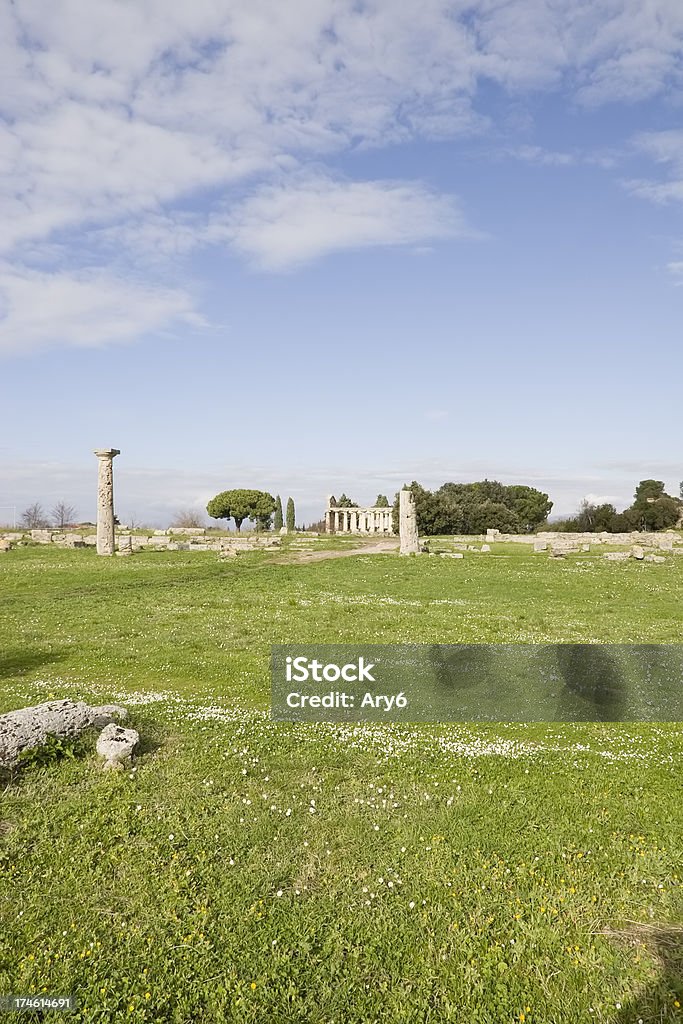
0;0;683;264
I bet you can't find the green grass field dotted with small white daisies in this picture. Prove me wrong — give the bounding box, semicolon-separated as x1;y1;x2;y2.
0;546;683;1024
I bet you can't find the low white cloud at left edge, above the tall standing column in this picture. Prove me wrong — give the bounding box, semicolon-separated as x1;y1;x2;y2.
0;267;202;354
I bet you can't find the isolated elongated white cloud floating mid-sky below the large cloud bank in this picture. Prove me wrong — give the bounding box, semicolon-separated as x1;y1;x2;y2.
225;176;472;270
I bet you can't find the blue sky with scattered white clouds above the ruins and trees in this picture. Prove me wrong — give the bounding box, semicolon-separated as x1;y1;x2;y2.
0;0;683;526
